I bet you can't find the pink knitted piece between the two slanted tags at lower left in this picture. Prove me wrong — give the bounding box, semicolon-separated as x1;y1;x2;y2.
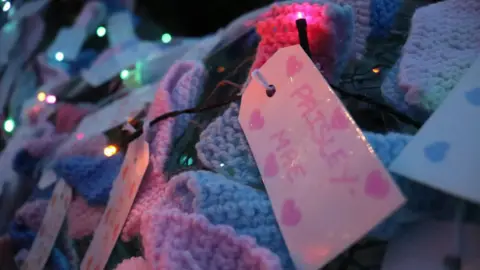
67;196;105;239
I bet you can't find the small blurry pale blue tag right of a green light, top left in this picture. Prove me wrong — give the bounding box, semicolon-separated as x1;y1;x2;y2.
107;12;136;47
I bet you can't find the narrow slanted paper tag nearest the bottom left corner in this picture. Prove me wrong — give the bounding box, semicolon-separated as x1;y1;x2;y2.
21;180;72;270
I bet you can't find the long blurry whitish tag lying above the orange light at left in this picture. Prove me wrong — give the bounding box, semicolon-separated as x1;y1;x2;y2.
75;85;157;139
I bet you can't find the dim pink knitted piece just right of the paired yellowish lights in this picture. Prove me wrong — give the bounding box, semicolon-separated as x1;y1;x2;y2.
55;104;90;133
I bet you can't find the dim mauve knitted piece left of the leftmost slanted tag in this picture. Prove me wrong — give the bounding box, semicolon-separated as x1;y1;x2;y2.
15;200;48;232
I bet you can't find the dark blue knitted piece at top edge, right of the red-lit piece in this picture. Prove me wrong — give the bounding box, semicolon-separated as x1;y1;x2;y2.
370;0;403;37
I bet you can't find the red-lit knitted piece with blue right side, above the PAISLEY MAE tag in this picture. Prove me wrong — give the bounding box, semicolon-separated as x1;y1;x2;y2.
252;1;354;81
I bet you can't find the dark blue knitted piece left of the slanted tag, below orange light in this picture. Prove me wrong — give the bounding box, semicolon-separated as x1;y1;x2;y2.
54;155;123;205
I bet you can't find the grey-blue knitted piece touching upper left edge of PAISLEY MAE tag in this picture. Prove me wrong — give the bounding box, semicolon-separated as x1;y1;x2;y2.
195;103;261;184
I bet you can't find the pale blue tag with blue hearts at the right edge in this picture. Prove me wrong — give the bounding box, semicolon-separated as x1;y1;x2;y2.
390;58;480;203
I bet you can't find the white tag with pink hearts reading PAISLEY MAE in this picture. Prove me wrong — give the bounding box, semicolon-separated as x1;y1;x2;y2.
239;45;405;270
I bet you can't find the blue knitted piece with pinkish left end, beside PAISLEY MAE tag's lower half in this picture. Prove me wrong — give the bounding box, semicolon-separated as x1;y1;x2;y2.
156;171;293;269
